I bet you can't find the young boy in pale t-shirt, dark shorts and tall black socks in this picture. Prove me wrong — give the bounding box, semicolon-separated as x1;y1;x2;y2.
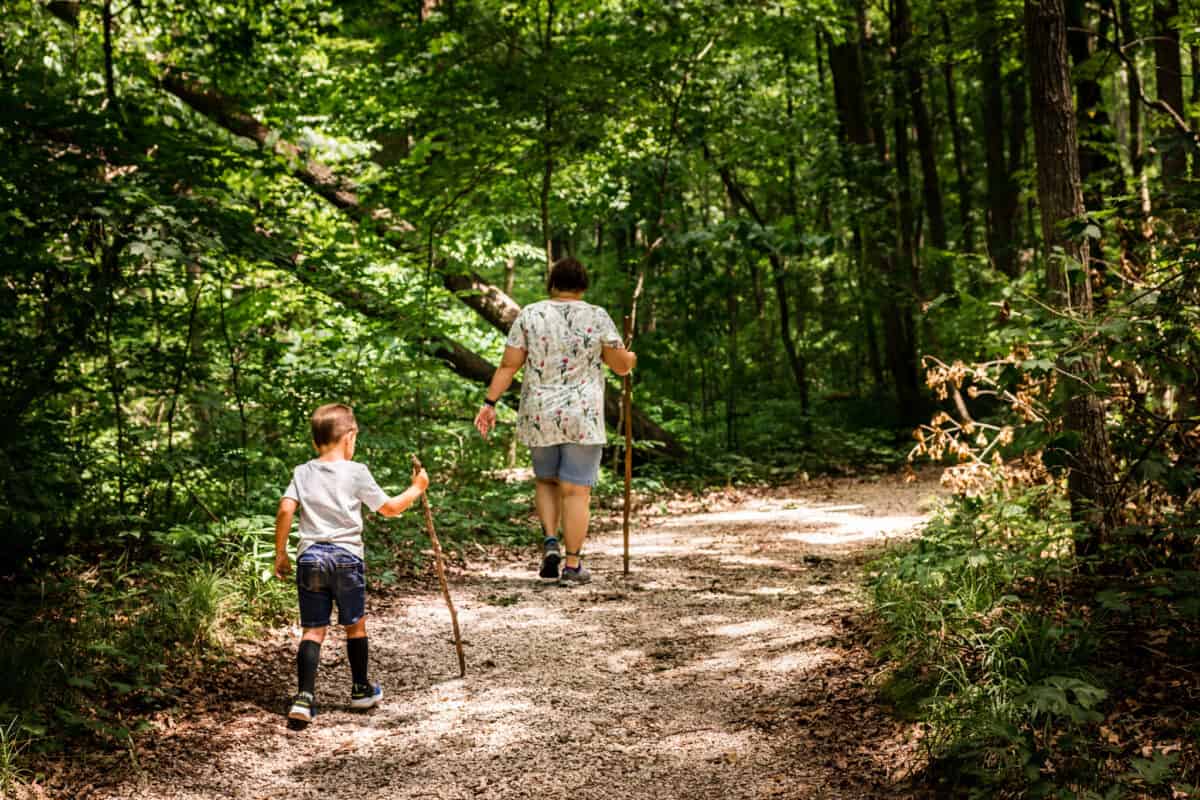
275;403;430;723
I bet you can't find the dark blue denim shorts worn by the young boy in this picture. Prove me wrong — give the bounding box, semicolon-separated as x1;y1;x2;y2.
296;542;367;627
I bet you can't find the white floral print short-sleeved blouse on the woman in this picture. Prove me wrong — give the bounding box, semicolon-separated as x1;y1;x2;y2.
508;300;623;447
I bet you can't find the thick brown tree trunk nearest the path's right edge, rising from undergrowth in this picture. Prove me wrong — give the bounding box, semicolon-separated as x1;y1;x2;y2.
1025;0;1115;554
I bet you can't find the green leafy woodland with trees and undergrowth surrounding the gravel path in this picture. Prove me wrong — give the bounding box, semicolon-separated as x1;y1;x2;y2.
0;0;1200;798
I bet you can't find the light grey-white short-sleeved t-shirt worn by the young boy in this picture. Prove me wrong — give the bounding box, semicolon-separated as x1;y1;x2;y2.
283;458;388;558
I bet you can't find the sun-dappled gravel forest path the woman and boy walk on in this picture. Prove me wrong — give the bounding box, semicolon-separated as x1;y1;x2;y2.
72;474;937;800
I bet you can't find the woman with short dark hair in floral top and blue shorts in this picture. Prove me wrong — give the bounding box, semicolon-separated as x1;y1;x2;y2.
475;257;637;585
